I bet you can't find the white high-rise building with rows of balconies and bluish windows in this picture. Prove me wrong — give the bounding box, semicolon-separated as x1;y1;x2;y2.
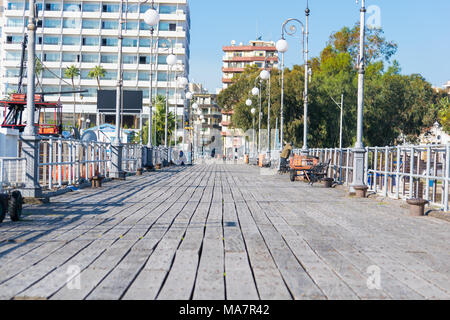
0;0;190;135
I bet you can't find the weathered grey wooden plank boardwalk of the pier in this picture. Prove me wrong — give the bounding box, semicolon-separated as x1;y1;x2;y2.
0;164;450;300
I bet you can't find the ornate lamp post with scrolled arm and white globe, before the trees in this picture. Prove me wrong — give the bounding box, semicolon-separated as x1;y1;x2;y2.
276;5;311;155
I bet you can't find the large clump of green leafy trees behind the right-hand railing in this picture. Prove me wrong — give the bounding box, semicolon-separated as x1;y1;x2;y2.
218;25;440;147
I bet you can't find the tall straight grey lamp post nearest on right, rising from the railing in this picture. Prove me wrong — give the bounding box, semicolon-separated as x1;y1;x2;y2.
352;0;368;197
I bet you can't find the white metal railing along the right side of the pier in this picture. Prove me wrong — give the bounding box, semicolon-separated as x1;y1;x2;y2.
310;144;450;211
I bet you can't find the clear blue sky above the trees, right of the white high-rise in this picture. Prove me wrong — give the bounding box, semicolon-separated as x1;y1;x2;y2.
189;0;450;92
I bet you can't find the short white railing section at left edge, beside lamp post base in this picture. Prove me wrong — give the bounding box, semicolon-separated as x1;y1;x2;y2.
0;158;26;191
